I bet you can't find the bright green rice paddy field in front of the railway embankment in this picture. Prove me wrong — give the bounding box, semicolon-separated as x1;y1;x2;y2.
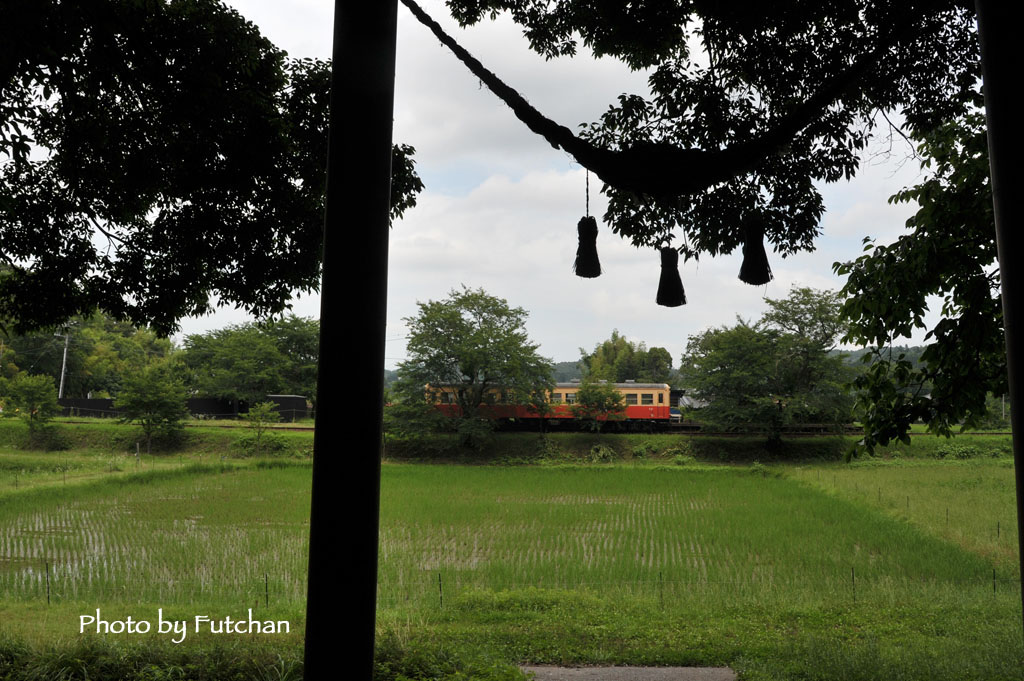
0;440;1024;679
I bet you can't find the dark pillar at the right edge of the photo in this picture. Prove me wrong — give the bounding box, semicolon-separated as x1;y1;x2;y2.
975;0;1024;624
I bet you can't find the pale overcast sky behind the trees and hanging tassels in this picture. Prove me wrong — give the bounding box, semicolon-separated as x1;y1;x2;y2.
182;0;920;368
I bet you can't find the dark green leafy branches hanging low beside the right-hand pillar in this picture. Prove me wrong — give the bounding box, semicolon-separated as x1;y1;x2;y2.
835;113;1007;450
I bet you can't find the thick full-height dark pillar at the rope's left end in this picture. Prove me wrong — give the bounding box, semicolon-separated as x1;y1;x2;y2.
305;0;397;681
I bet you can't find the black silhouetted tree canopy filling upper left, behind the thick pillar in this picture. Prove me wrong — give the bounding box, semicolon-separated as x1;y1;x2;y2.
0;0;421;334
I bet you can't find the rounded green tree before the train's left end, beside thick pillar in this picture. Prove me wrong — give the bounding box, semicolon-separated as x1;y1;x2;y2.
395;287;553;436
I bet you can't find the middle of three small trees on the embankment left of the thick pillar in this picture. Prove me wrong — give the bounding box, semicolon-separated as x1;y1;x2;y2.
114;364;188;454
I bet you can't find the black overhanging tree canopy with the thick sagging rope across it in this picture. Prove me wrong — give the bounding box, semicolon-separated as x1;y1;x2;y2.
402;0;980;270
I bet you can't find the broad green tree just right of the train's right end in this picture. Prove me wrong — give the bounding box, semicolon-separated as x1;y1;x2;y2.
681;288;853;438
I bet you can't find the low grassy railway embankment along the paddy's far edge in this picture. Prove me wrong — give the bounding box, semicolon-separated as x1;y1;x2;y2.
0;419;1012;465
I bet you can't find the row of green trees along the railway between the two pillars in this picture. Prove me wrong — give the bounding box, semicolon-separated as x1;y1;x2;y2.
385;287;1009;442
